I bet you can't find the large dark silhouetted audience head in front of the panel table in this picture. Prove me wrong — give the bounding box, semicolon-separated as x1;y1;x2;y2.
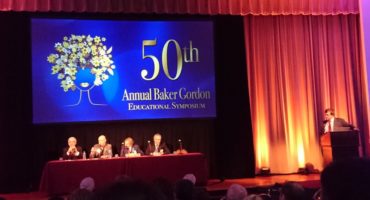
93;180;166;200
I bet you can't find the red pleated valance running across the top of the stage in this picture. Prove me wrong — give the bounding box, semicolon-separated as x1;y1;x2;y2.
0;0;359;15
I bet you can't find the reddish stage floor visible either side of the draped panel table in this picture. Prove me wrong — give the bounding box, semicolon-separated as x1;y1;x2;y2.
0;174;320;200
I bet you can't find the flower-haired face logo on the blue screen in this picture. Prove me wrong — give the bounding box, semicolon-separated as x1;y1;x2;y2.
47;34;116;106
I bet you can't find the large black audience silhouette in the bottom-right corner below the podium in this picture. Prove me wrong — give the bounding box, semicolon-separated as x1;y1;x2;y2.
321;159;370;200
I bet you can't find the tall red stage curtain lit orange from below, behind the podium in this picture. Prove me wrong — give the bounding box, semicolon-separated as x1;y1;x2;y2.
244;15;369;173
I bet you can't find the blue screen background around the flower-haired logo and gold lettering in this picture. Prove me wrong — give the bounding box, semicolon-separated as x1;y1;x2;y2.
31;19;216;123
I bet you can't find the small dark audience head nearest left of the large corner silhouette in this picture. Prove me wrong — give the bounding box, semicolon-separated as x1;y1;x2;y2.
279;182;306;200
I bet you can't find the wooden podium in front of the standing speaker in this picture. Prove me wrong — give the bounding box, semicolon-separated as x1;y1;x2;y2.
320;130;360;166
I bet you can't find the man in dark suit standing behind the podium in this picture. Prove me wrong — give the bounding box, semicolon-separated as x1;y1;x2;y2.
321;108;354;134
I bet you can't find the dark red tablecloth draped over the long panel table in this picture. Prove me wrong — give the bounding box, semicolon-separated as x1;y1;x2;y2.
40;153;208;195
